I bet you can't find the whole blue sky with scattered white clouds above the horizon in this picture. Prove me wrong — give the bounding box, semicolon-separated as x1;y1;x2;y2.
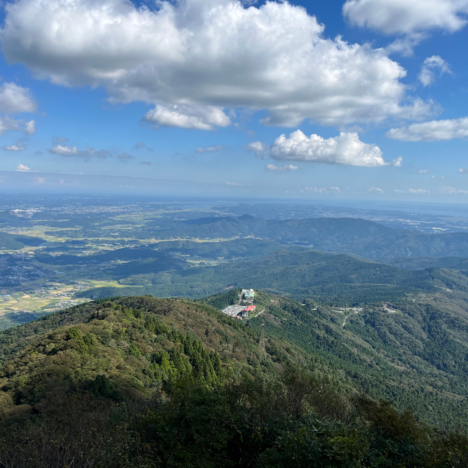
0;0;468;203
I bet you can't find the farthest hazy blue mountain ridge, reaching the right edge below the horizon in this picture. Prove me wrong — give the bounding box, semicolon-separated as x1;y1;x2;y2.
148;215;468;260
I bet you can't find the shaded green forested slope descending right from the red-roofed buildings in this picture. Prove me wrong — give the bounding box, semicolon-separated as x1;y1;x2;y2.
241;292;468;427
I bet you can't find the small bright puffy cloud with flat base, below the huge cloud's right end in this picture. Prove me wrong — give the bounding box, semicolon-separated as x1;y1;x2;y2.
269;130;401;167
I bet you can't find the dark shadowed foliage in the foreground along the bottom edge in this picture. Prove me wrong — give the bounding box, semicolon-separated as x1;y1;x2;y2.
0;371;468;468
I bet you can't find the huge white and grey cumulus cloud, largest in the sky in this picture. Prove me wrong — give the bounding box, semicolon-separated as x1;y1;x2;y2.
0;0;432;130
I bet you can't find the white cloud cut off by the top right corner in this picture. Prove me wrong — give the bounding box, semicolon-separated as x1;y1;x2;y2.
343;0;468;34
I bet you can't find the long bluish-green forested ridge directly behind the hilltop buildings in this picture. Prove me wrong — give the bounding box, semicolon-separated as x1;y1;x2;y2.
78;250;468;303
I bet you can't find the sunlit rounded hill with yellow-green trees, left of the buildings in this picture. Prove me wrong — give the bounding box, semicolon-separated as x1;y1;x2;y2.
0;297;326;405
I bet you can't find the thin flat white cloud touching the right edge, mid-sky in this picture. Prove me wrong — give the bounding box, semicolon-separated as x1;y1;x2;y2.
387;117;468;141
